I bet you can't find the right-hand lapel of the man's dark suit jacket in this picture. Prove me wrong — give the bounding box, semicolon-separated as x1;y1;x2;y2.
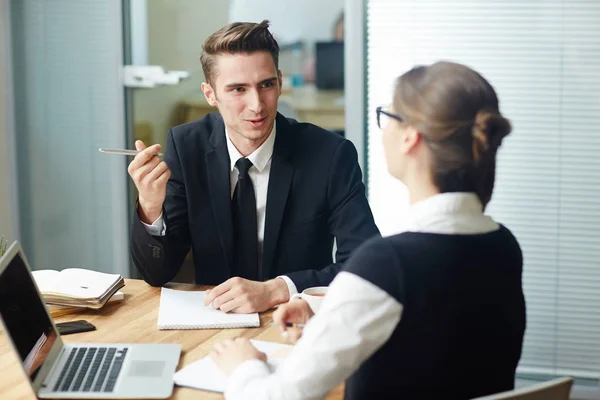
261;114;294;278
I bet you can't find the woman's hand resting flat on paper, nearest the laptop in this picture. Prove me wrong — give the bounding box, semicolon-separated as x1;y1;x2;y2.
210;338;267;376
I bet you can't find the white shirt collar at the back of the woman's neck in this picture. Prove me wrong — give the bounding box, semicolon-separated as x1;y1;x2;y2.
406;193;499;235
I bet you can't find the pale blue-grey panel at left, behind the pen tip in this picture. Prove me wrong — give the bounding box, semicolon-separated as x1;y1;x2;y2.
9;0;130;276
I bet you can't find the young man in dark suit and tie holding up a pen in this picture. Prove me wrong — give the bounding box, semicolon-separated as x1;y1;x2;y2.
129;21;379;313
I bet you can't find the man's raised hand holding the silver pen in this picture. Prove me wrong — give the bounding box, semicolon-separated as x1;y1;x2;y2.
127;140;171;224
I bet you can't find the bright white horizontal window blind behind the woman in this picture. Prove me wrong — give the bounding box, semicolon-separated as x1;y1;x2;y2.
366;0;600;385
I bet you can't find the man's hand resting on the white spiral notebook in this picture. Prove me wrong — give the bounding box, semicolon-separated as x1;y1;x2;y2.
204;277;290;314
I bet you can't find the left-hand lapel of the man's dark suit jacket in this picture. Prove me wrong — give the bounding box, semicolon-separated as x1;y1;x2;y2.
206;119;233;275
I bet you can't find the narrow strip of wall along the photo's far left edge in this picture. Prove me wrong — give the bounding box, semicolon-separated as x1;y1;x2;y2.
0;1;16;241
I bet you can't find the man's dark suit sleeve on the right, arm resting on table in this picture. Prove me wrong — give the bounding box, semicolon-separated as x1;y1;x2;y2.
287;140;380;292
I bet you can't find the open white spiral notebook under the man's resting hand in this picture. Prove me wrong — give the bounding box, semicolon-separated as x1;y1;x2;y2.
158;288;260;330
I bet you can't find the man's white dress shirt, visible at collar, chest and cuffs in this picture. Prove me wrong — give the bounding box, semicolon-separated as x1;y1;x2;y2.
142;122;298;297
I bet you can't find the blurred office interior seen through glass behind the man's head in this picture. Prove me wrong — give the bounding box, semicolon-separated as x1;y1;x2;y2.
131;0;344;152
